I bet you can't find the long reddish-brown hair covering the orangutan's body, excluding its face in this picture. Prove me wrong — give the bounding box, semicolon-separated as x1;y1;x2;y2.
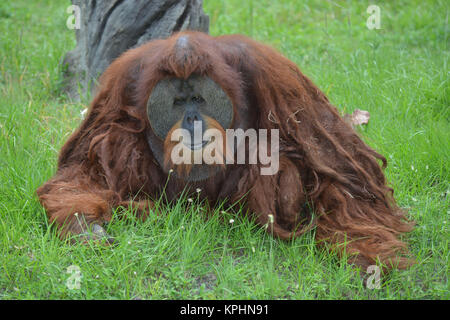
38;32;412;267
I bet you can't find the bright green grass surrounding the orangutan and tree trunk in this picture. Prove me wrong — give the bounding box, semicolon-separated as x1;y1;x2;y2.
0;0;450;299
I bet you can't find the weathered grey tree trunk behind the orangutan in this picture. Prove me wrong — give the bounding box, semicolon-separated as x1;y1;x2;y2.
63;0;209;100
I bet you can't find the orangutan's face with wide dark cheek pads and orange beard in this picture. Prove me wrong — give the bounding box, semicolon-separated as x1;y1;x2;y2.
147;75;234;181
